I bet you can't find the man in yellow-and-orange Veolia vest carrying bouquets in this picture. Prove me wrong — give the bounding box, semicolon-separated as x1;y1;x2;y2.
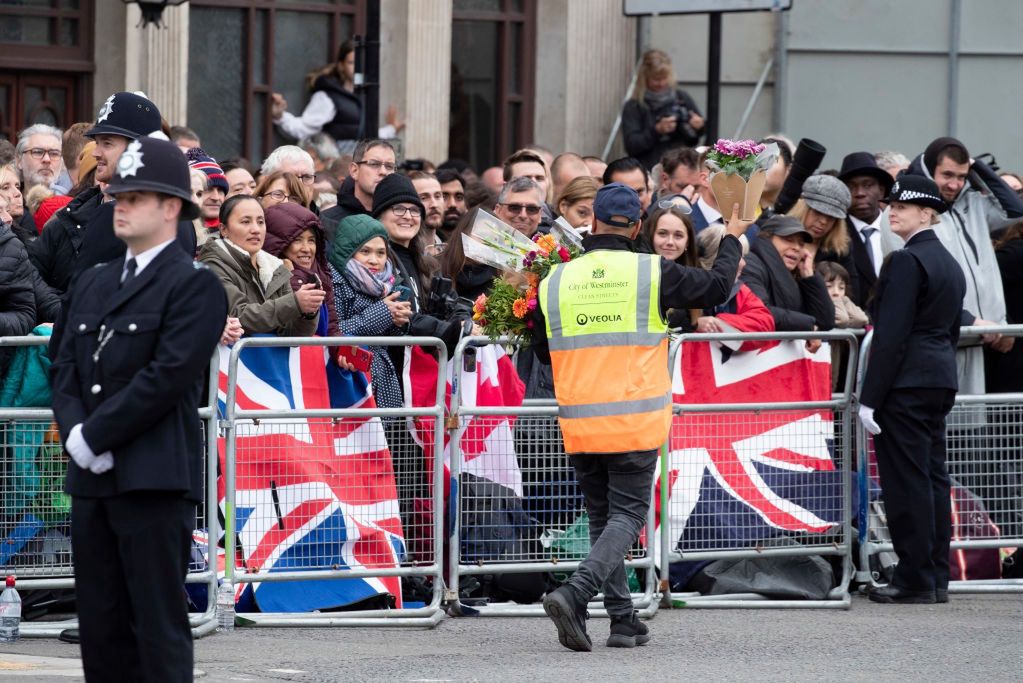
533;183;750;651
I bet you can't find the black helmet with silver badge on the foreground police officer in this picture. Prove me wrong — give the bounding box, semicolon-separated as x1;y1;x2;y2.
106;137;198;220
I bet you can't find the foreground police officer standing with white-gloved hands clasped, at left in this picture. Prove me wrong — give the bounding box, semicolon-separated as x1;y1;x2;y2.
50;138;227;681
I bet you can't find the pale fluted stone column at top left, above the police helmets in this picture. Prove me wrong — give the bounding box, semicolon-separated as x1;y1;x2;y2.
125;3;188;126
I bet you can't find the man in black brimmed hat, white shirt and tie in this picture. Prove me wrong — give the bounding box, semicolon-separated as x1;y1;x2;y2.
838;151;894;306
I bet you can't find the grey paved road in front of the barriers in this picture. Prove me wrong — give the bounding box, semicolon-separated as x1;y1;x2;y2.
0;594;1023;683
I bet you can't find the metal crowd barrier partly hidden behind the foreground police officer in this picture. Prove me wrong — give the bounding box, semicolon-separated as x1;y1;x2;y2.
0;335;219;638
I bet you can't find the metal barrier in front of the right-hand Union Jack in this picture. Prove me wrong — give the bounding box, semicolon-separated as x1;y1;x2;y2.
660;330;858;609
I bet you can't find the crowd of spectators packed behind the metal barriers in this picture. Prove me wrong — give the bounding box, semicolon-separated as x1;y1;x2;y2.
0;46;1023;543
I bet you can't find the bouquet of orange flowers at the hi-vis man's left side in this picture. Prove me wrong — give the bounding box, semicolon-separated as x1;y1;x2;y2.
465;229;582;344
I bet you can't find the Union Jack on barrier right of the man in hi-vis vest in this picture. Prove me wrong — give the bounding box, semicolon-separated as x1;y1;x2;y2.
658;342;842;551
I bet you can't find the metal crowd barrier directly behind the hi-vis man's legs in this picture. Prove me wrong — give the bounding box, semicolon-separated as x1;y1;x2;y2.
447;336;659;618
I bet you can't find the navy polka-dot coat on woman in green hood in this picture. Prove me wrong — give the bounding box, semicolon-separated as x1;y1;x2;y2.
331;269;404;408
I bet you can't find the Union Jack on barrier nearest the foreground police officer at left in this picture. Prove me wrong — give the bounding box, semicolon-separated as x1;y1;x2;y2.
213;339;405;612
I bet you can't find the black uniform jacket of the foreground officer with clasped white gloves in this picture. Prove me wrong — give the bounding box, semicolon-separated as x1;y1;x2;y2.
50;244;227;501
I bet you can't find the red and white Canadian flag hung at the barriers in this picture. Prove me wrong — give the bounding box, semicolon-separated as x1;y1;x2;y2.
405;345;526;498
